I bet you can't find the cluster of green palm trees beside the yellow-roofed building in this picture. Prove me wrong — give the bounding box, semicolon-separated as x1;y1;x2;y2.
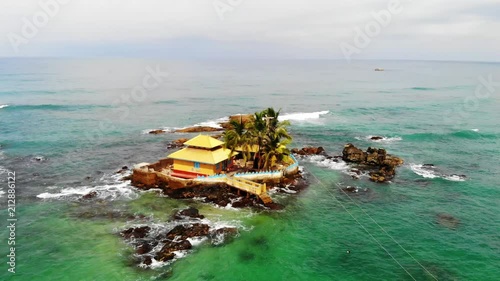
223;107;292;169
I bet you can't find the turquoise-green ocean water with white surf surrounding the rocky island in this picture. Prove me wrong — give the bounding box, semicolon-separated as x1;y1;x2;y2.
0;59;500;281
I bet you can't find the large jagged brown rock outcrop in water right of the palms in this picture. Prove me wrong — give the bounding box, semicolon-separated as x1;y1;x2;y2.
342;143;404;182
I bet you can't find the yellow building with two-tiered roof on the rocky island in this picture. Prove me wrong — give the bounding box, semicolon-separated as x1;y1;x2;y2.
168;135;238;178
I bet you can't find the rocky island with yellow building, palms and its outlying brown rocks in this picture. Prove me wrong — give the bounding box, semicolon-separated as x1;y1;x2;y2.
127;108;403;267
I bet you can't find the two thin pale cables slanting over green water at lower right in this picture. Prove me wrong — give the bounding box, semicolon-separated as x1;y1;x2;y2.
309;166;438;281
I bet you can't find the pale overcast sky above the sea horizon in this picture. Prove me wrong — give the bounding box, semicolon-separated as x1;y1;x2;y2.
0;0;500;61
